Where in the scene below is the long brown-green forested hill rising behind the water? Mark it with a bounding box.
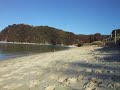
[0,24,107,45]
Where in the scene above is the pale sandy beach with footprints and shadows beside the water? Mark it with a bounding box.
[0,46,120,90]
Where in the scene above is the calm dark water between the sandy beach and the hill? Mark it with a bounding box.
[0,43,67,60]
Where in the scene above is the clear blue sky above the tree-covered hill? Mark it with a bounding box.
[0,0,120,34]
